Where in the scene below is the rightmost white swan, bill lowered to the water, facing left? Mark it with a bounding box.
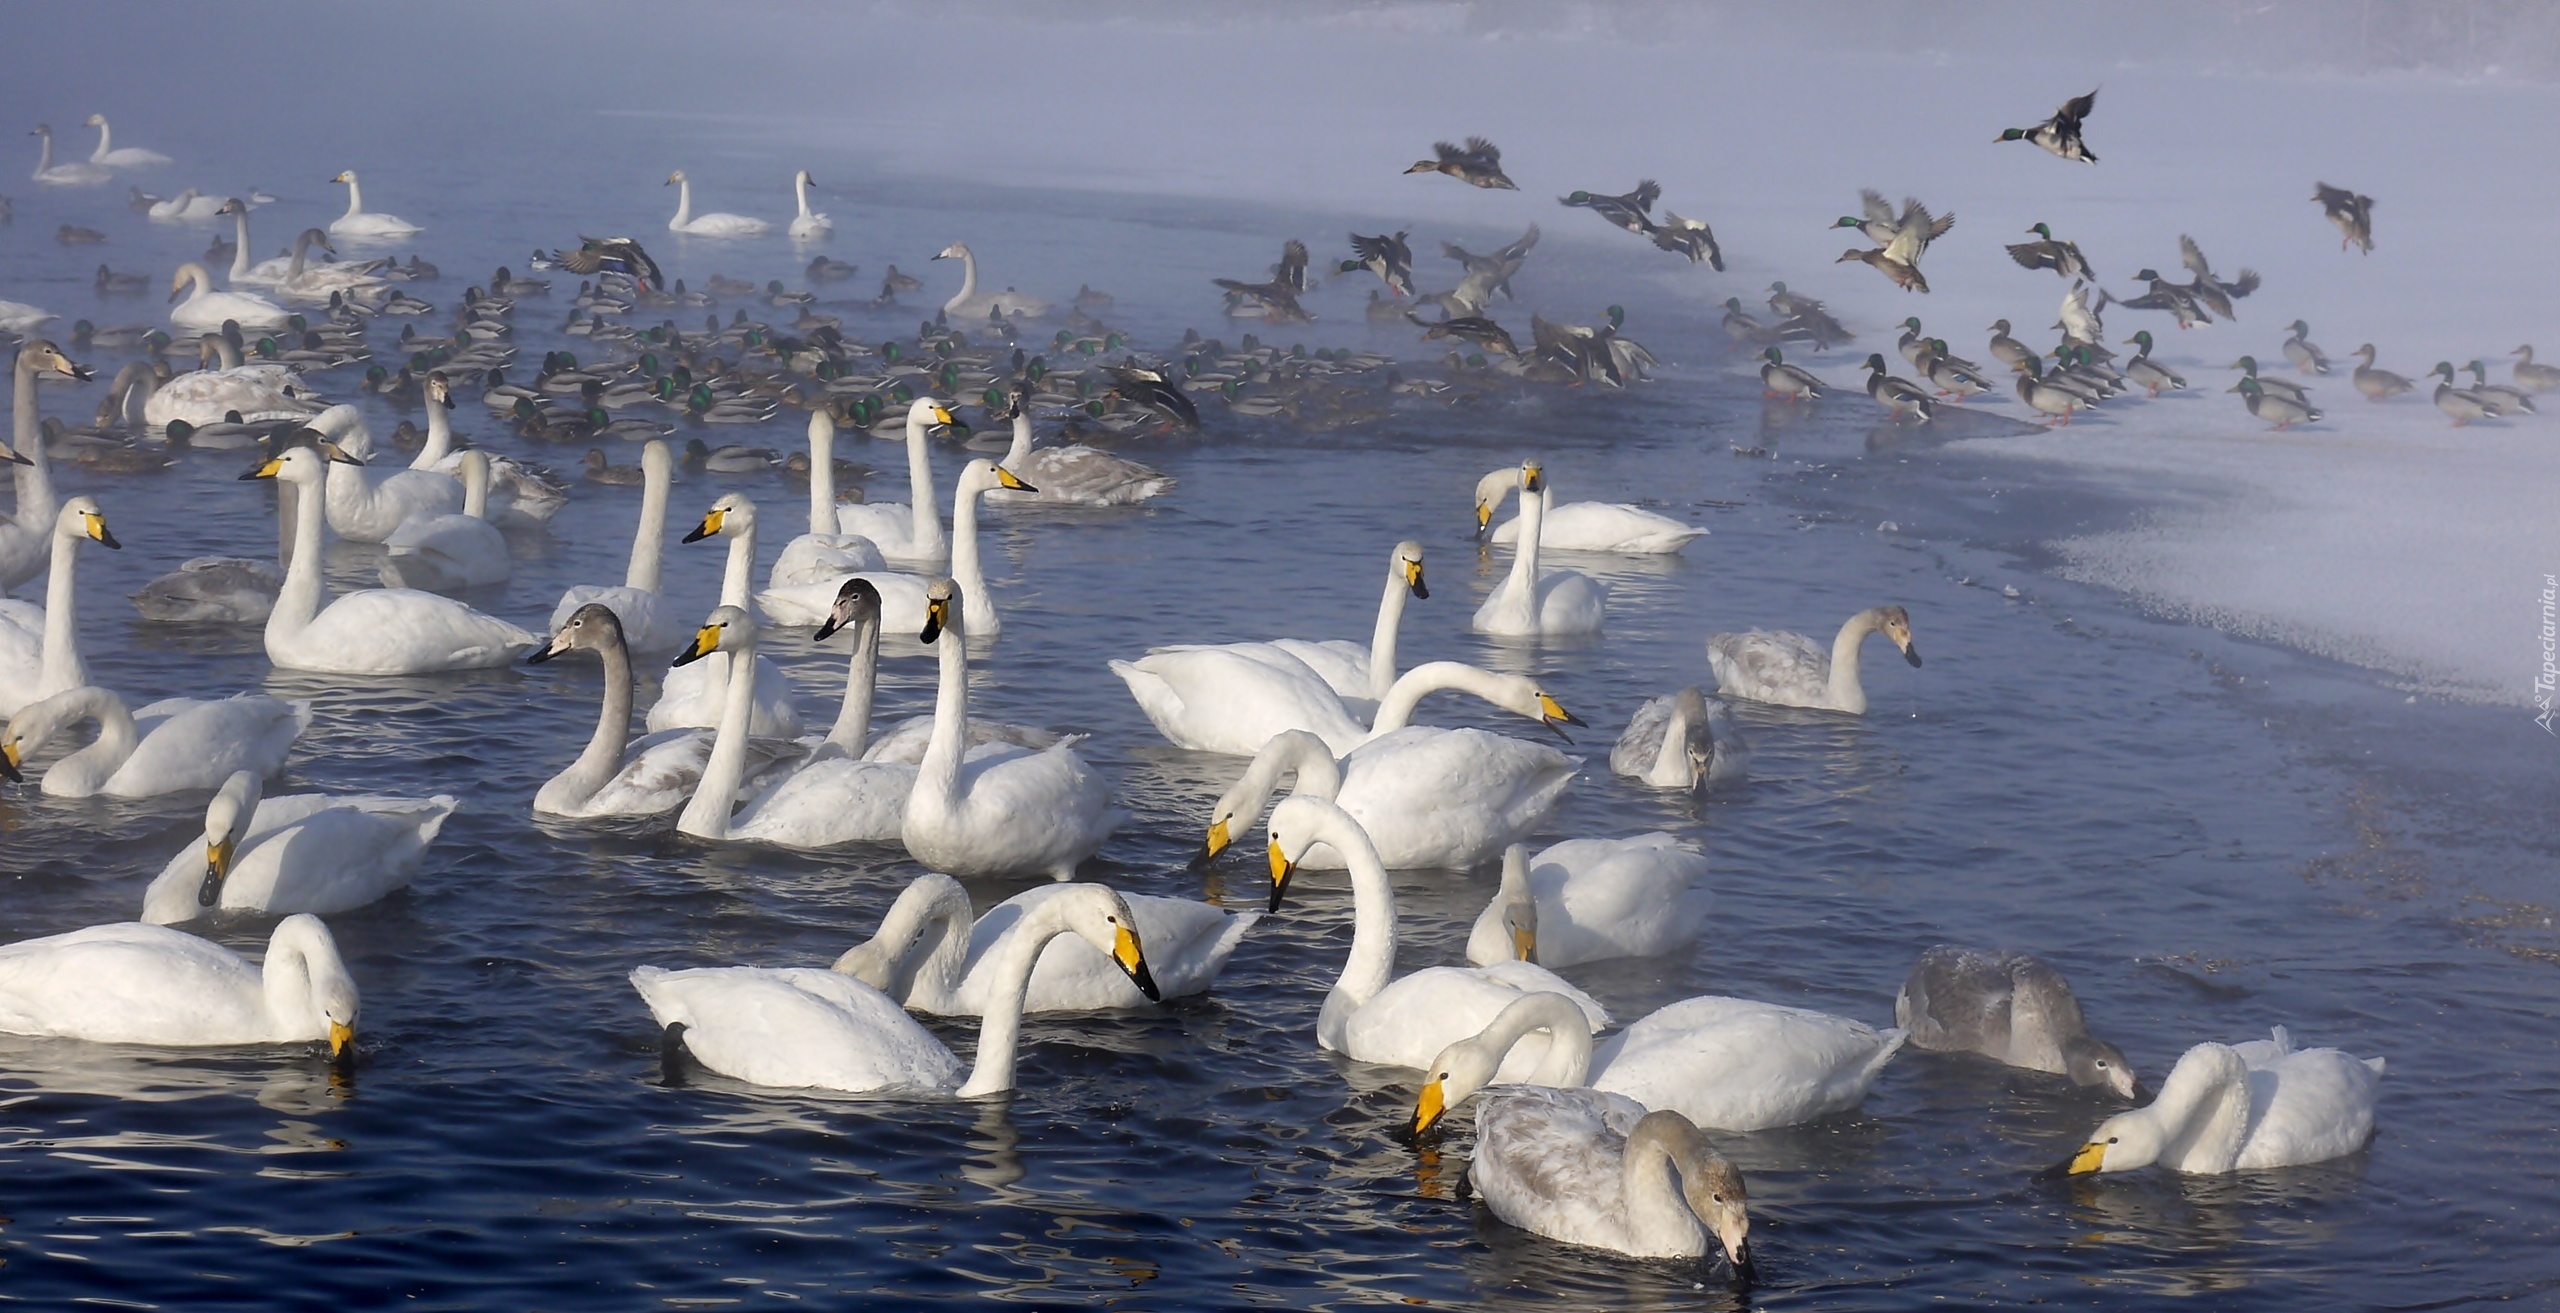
[2063,1026,2383,1175]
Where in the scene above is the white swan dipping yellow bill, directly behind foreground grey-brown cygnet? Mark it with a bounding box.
[1413,996,1905,1134]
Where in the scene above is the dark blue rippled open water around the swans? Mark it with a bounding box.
[0,58,2560,1310]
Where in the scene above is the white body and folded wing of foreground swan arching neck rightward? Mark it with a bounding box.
[632,967,960,1093]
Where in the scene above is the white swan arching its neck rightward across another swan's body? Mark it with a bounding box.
[632,886,1155,1098]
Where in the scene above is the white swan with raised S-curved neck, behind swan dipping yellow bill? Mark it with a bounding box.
[1270,796,1608,1080]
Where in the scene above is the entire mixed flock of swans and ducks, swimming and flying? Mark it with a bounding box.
[0,97,2426,1272]
